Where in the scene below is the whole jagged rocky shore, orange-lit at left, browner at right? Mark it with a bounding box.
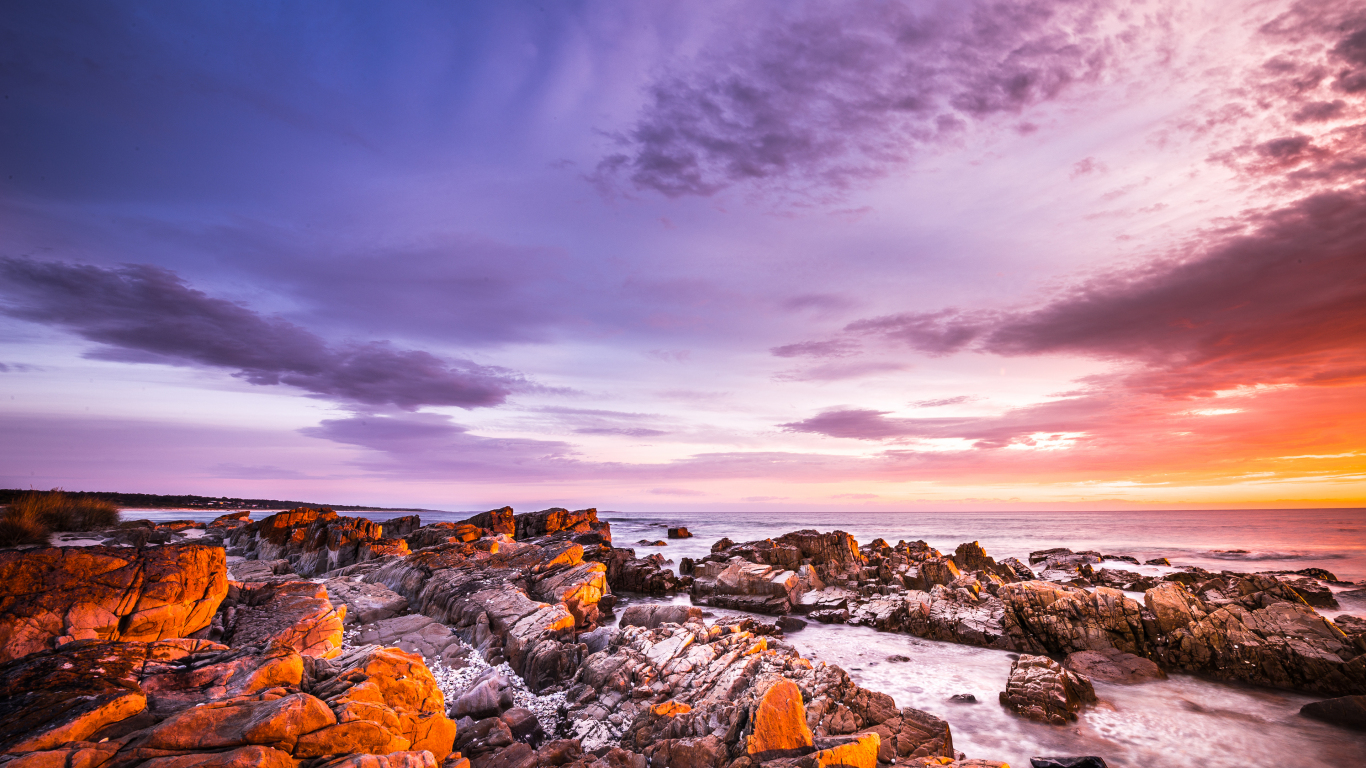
[0,507,1366,768]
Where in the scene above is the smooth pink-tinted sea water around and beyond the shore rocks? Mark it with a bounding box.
[124,510,1366,768]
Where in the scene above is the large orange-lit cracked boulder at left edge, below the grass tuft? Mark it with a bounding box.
[0,544,228,661]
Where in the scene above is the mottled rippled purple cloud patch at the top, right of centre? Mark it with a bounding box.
[598,0,1160,197]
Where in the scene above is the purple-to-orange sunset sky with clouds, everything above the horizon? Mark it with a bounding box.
[0,0,1366,512]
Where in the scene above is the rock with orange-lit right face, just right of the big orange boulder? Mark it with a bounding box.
[223,581,346,659]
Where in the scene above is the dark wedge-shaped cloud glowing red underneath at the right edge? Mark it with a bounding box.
[847,184,1366,396]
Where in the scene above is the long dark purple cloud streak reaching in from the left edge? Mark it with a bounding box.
[0,257,527,410]
